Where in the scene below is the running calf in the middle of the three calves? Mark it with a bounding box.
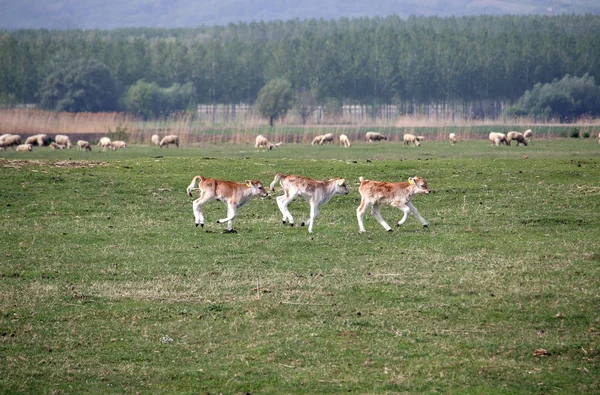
[270,174,349,233]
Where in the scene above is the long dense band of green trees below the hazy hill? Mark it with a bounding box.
[0,15,600,120]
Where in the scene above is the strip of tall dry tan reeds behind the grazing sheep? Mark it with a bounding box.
[0,110,600,144]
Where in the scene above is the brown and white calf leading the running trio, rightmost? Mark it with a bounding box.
[356,177,429,233]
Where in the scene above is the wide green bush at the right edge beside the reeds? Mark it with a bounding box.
[508,74,600,121]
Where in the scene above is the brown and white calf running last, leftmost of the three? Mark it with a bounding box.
[187,176,268,233]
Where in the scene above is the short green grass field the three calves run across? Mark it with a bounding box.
[0,139,600,394]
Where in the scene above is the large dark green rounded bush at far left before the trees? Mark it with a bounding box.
[38,52,118,112]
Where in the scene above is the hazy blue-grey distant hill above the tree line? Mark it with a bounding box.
[0,0,600,29]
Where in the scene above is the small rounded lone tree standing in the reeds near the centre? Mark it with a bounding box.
[256,79,294,126]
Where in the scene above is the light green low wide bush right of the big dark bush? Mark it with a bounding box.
[122,80,194,118]
